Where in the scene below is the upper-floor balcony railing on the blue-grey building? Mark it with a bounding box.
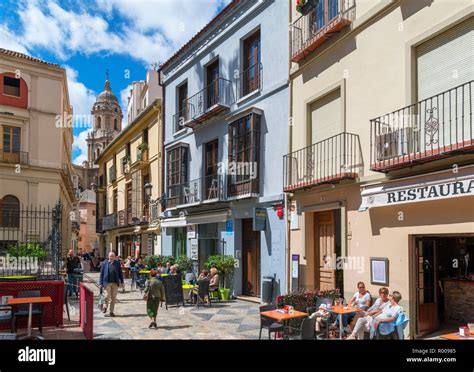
[173,78,234,131]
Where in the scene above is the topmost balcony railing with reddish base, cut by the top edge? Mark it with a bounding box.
[291,0,355,62]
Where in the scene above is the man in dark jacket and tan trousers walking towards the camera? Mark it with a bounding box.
[99,252,123,316]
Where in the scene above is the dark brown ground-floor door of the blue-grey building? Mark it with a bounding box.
[242,219,260,297]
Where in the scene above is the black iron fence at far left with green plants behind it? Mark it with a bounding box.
[0,203,62,280]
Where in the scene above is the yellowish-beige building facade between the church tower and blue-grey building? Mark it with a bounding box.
[97,100,162,257]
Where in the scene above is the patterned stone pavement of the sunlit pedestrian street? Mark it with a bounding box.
[85,273,266,340]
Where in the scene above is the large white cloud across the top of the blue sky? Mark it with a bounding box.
[12,0,230,64]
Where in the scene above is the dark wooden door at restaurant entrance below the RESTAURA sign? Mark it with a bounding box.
[415,238,439,336]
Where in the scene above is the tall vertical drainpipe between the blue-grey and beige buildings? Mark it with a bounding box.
[283,2,293,293]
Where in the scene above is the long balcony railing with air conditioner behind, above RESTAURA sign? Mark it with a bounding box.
[370,81,474,172]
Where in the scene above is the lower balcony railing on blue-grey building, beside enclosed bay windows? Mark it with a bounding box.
[166,174,225,208]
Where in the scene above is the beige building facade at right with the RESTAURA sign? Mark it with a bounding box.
[284,0,474,337]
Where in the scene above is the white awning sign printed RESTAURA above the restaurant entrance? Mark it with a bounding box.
[359,166,474,212]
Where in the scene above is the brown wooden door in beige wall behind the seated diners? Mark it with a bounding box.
[314,210,336,290]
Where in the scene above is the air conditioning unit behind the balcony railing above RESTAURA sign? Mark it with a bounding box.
[375,127,420,161]
